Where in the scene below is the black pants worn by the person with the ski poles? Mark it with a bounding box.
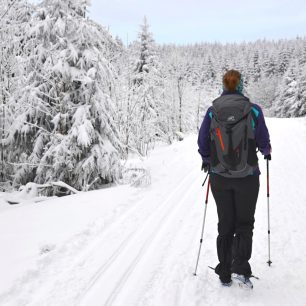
[210,174,259,282]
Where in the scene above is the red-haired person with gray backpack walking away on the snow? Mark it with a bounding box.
[198,70,271,287]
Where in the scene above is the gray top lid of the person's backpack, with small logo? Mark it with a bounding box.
[213,94,252,124]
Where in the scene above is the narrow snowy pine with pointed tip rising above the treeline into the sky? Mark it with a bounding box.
[129,17,162,155]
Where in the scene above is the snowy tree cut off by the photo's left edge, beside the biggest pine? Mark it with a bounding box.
[0,0,33,188]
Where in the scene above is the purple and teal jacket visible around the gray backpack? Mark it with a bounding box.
[198,91,271,175]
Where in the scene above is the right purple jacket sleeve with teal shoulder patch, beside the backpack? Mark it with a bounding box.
[253,104,271,155]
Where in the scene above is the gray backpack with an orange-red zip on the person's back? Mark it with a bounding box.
[210,94,258,178]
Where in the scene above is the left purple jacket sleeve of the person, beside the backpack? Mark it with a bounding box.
[198,107,211,162]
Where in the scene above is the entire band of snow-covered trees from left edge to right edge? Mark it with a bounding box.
[0,0,306,190]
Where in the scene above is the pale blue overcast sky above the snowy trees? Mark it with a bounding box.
[90,0,306,44]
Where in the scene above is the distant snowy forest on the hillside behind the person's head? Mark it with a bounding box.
[160,37,306,117]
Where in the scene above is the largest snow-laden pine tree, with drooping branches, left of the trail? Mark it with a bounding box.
[6,0,121,190]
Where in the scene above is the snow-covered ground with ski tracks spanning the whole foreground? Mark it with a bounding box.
[0,118,306,306]
